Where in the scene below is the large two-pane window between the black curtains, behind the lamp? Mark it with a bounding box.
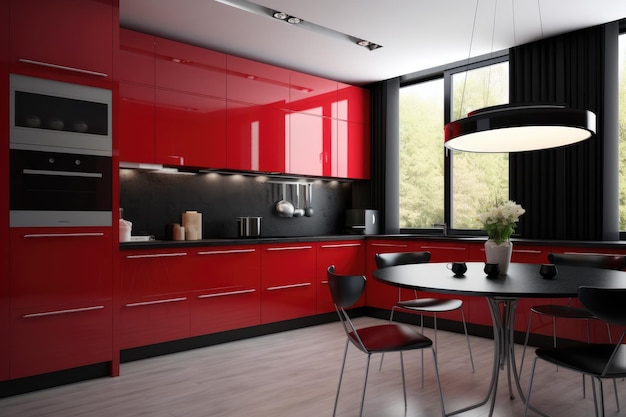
[399,58,509,229]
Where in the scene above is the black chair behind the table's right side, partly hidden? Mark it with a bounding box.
[519,253,626,410]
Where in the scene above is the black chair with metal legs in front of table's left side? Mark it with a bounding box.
[327,265,445,416]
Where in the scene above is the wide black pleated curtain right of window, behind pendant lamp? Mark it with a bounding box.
[510,22,619,240]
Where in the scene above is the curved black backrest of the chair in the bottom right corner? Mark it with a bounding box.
[578,287,626,326]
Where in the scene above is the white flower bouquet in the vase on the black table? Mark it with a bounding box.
[478,200,526,245]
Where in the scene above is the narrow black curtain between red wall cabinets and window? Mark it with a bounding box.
[370,78,400,234]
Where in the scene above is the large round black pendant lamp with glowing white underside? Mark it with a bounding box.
[444,0,596,153]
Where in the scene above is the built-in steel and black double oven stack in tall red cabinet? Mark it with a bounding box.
[9,74,112,227]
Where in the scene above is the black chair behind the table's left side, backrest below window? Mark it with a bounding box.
[374,251,474,385]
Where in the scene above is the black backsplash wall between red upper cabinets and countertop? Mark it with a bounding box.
[120,169,352,240]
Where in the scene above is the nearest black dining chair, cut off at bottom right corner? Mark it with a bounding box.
[524,286,626,417]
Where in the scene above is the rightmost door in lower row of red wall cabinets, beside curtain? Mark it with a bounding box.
[332,120,370,179]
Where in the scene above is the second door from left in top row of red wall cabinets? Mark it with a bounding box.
[156,38,226,99]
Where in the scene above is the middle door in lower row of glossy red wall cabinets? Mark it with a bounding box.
[226,101,290,173]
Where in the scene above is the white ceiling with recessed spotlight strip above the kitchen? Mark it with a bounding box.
[120,0,626,84]
